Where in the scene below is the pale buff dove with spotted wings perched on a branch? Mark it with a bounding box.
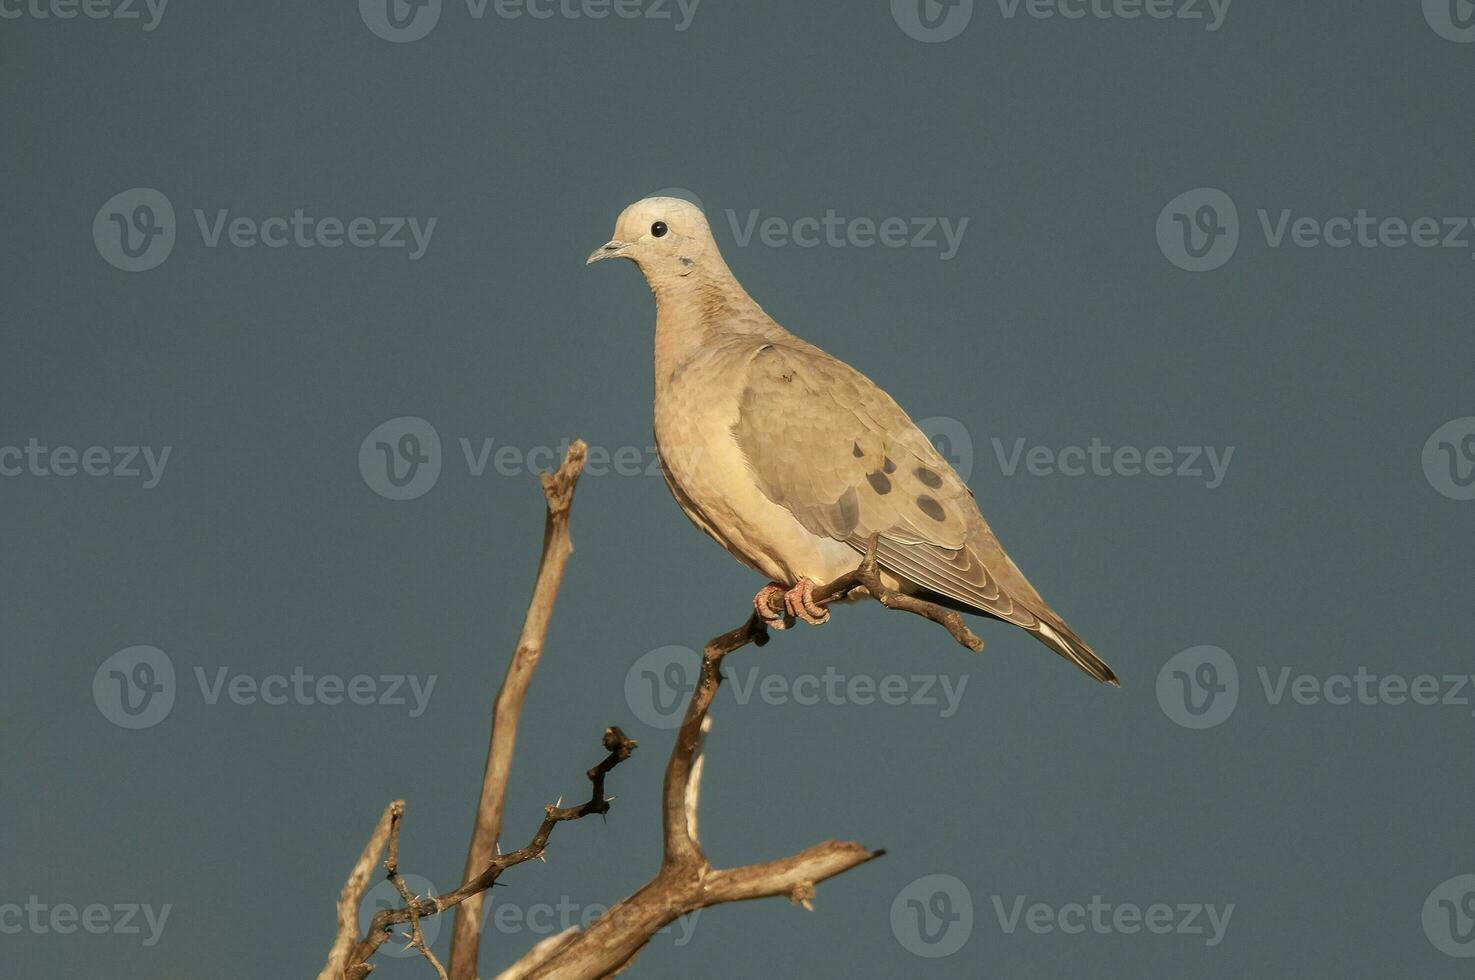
[587,198,1120,686]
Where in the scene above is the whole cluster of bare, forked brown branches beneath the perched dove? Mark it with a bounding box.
[319,441,984,980]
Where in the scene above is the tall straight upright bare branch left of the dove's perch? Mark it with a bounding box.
[450,440,589,980]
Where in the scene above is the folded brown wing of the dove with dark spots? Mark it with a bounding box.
[733,342,1053,630]
